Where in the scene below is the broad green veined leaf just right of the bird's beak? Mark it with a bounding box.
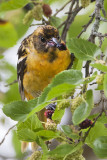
[67,38,101,60]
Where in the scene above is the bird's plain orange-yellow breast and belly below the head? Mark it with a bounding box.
[23,50,71,97]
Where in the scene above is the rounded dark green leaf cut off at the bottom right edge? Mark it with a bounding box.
[93,136,107,158]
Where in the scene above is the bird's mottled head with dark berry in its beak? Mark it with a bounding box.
[33,25,66,53]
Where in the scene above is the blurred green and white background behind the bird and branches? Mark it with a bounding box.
[0,0,107,160]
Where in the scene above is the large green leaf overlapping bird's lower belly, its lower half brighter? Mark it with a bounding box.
[39,69,82,103]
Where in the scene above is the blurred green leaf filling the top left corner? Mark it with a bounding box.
[0,0,30,12]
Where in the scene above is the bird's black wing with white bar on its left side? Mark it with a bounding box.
[17,44,27,100]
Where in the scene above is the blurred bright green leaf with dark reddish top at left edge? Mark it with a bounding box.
[0,21,18,48]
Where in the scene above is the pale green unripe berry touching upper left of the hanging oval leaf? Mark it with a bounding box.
[71,96,83,113]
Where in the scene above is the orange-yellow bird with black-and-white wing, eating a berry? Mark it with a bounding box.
[17,25,72,151]
